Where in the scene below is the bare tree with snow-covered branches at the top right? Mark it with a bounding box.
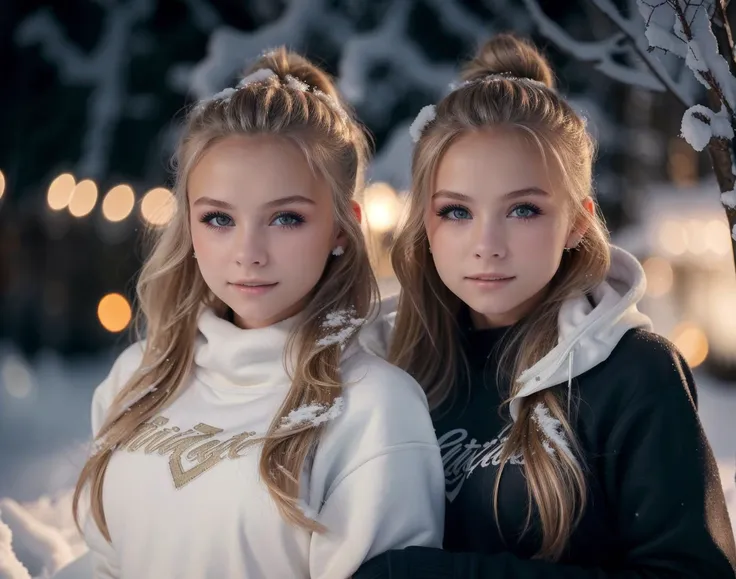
[524,0,736,267]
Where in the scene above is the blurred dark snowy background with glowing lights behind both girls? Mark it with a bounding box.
[0,0,736,572]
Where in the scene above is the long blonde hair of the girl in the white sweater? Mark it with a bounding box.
[73,48,378,541]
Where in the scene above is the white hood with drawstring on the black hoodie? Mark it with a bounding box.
[359,246,652,420]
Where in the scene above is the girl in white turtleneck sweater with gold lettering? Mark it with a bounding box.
[74,49,444,579]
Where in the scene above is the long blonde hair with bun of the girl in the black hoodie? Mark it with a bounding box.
[389,34,610,560]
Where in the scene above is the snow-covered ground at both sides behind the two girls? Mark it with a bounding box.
[0,348,736,579]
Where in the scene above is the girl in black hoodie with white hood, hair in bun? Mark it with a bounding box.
[354,35,736,579]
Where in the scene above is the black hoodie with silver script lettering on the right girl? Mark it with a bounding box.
[353,252,736,579]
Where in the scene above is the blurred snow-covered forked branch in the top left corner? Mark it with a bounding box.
[16,0,154,177]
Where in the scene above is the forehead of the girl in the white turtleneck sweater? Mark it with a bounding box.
[187,135,322,203]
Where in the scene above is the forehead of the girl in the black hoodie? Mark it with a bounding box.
[434,128,557,197]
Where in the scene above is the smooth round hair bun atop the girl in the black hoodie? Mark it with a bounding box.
[460,34,555,88]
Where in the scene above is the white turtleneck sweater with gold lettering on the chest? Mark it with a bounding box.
[86,310,444,579]
